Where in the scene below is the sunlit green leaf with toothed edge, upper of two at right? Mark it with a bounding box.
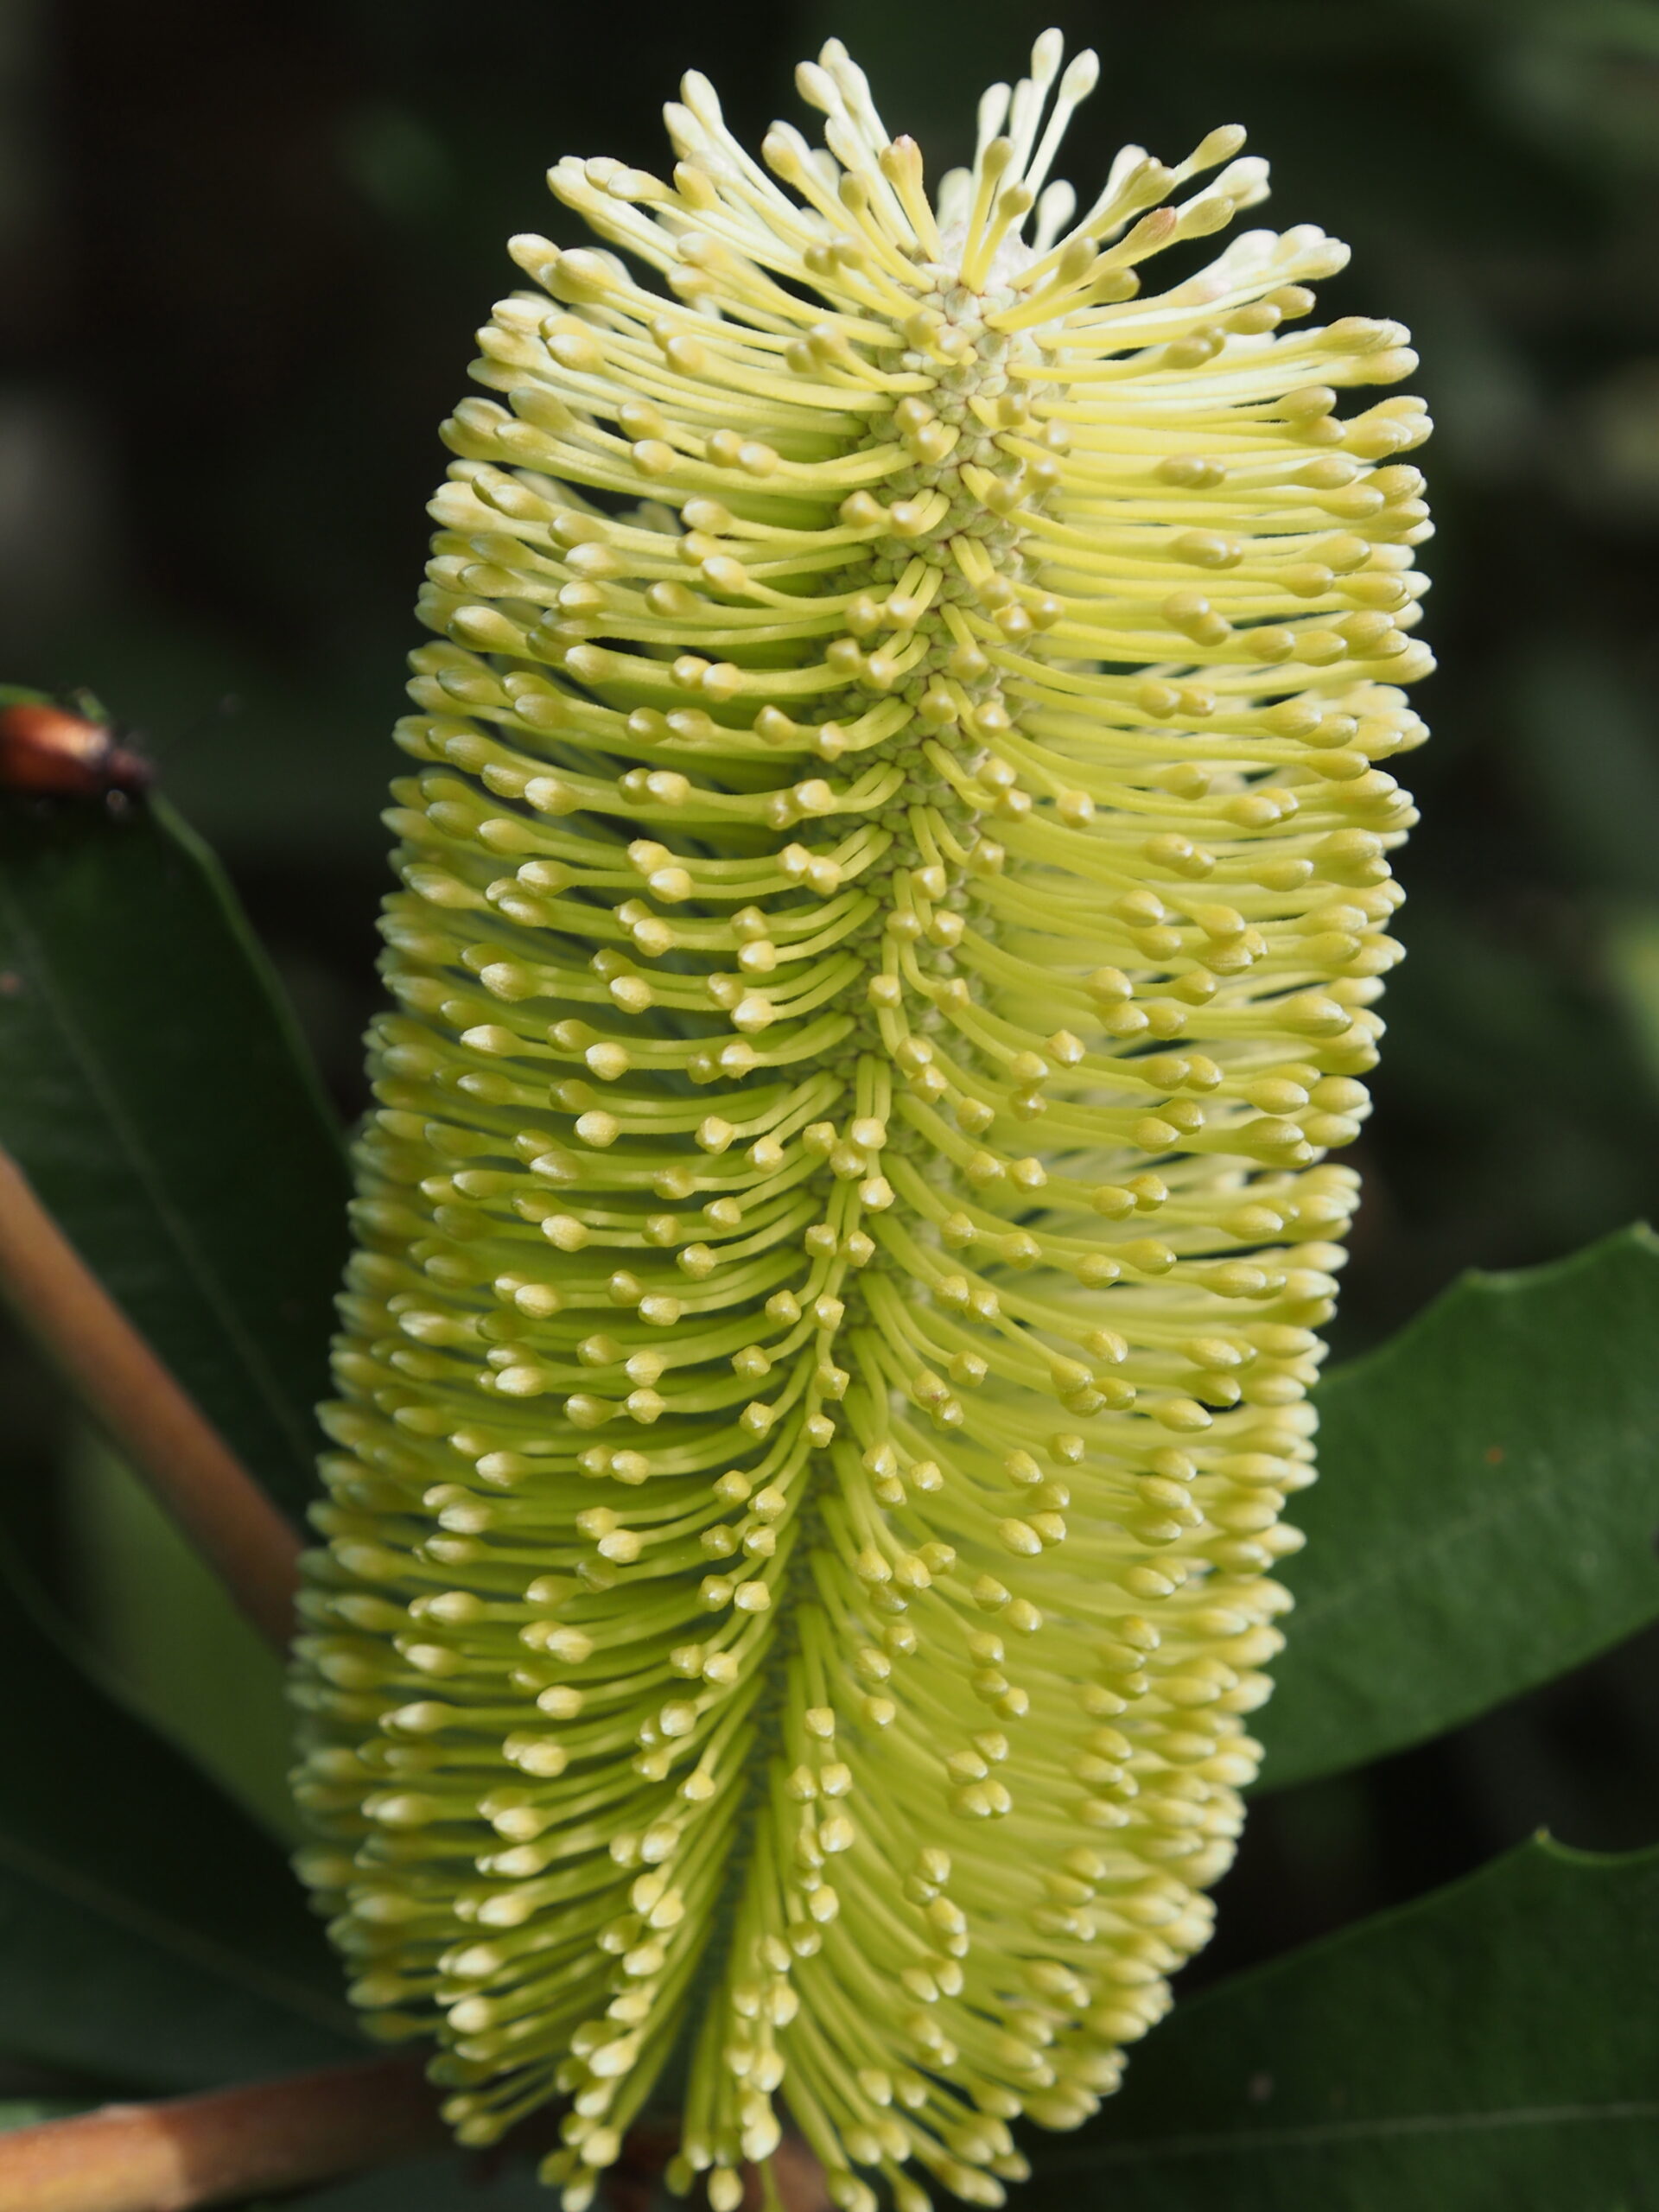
[1259,1228,1659,1787]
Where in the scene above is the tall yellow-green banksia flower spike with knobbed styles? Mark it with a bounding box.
[299,33,1429,2212]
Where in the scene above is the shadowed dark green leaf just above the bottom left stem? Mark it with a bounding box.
[0,1522,363,2094]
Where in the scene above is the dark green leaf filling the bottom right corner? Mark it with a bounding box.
[1028,1842,1659,2212]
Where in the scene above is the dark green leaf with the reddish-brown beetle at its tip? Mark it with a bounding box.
[0,760,347,1516]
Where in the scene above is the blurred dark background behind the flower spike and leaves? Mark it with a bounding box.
[0,0,1659,2052]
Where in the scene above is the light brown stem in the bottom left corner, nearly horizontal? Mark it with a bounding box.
[0,2059,449,2212]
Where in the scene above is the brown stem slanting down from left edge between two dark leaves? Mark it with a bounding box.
[0,1153,301,1650]
